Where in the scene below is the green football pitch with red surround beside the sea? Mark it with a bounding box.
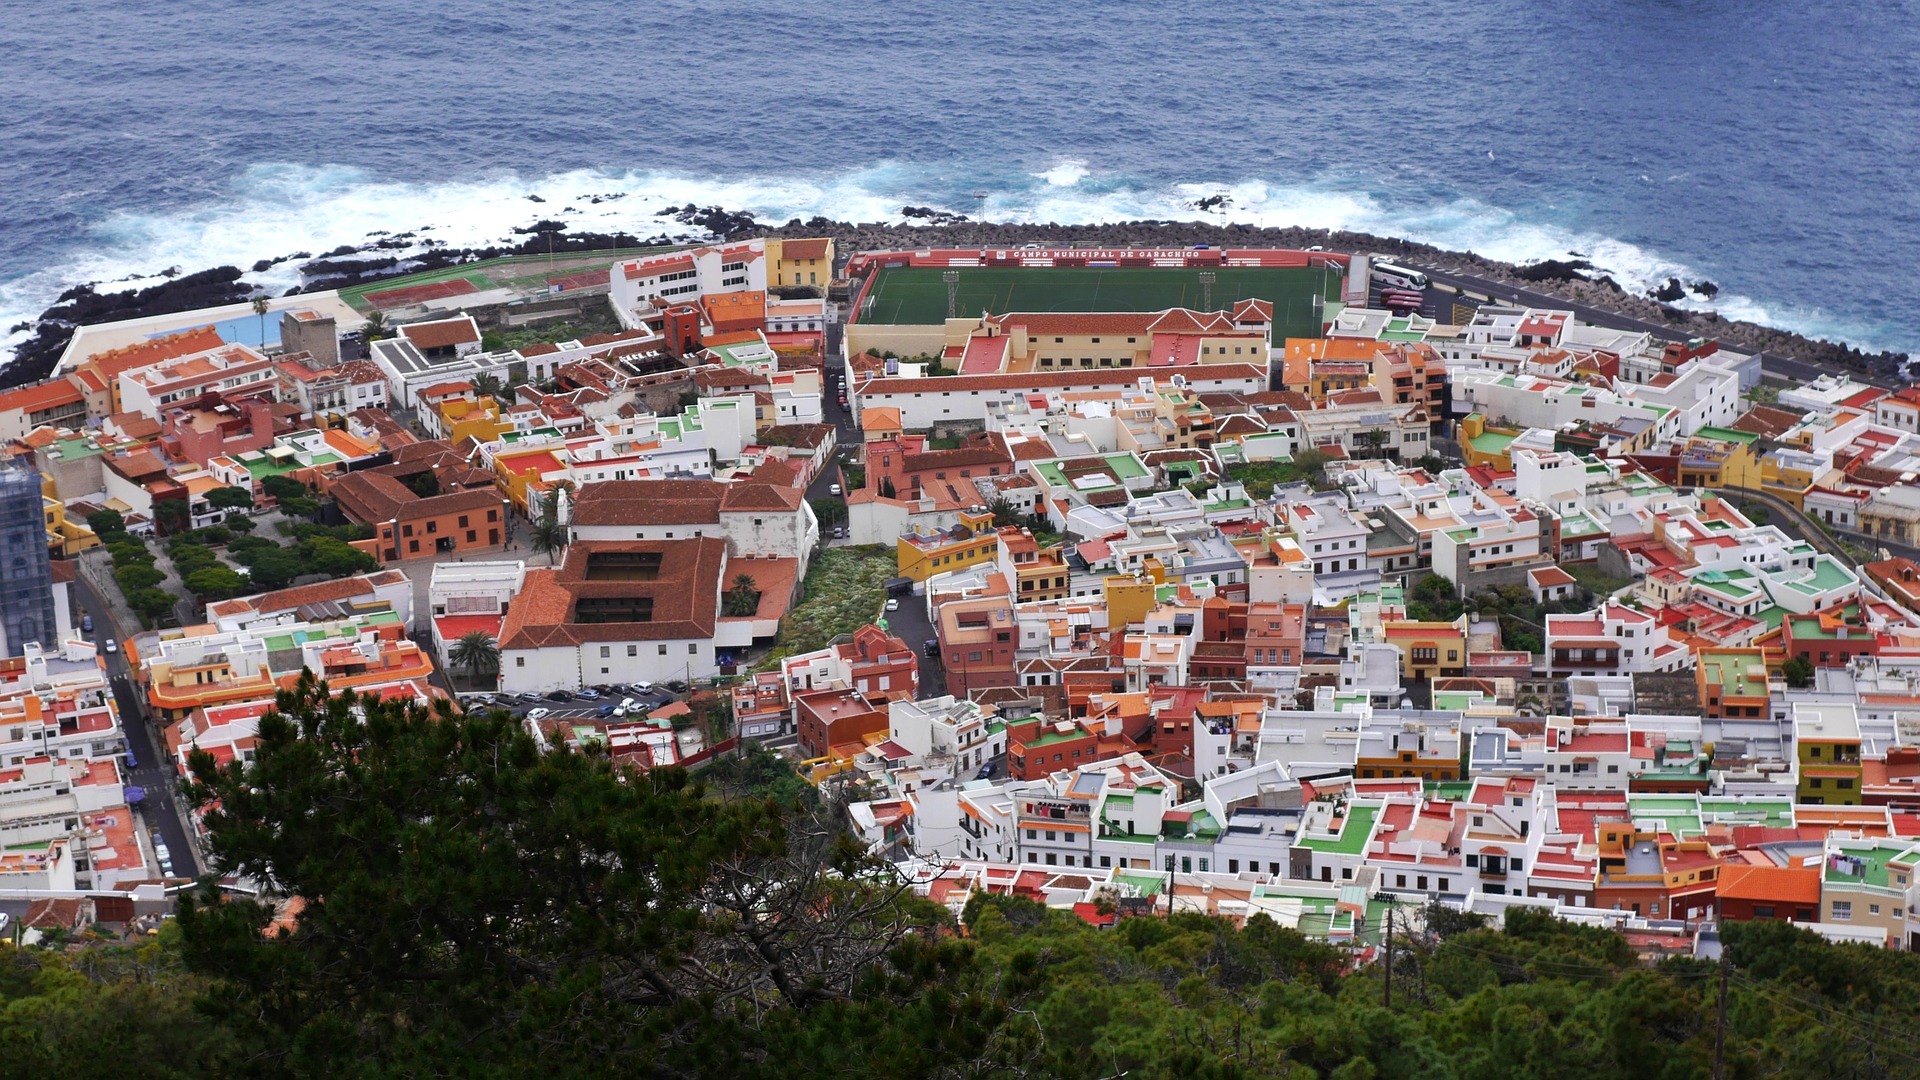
[854,267,1340,340]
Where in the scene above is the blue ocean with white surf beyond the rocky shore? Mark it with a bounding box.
[0,0,1920,352]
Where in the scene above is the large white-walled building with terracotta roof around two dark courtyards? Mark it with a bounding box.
[499,536,728,694]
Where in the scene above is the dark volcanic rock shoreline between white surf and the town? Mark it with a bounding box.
[0,204,1907,388]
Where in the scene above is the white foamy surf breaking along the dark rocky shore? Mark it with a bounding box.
[0,158,1912,350]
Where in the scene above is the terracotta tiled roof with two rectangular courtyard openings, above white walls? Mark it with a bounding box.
[499,536,726,650]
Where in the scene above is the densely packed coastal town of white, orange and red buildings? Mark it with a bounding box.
[0,238,1920,955]
